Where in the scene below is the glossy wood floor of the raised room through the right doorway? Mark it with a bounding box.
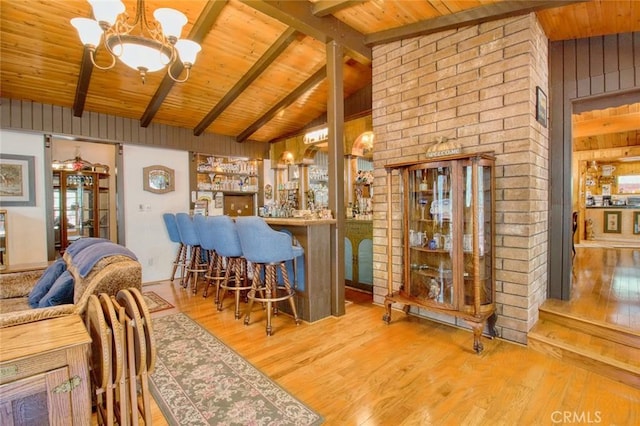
[546,247,640,330]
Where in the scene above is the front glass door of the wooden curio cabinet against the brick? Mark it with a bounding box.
[405,165,456,307]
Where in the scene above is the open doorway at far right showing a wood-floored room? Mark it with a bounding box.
[559,99,640,329]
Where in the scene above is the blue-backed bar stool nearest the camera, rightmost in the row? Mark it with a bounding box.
[236,216,304,336]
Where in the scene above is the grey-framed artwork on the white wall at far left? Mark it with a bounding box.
[0,154,36,206]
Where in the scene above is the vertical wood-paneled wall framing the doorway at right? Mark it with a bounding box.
[549,32,640,300]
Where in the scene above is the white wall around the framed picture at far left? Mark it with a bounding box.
[0,129,47,266]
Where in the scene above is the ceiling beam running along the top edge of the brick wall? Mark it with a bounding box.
[364,0,585,46]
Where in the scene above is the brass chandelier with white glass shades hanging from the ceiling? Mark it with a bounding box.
[71,0,200,84]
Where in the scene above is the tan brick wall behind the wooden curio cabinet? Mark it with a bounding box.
[372,14,549,343]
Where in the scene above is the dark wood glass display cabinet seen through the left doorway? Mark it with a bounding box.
[53,170,110,253]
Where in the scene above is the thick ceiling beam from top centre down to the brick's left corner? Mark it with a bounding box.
[242,0,371,65]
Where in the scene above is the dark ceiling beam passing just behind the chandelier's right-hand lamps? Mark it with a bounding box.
[140,0,228,127]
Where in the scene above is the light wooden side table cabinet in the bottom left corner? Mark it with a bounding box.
[0,315,91,425]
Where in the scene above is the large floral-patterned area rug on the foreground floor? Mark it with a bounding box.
[150,313,323,426]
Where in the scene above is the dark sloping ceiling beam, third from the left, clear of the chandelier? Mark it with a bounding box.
[193,27,300,136]
